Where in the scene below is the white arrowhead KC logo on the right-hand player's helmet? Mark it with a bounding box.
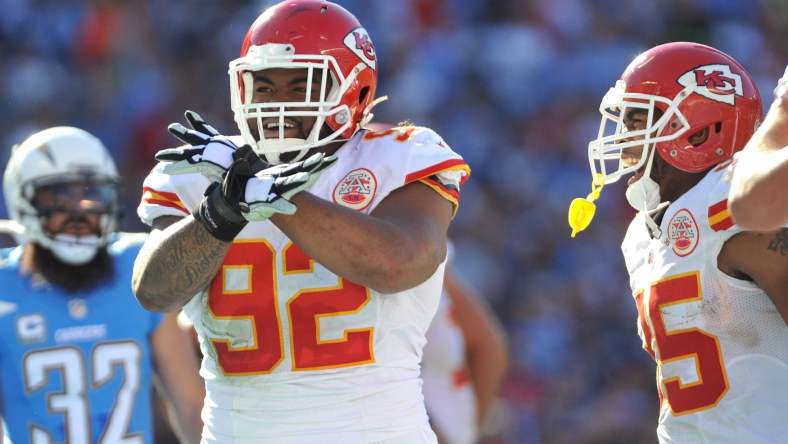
[678,65,744,105]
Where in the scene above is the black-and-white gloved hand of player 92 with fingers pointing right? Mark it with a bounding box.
[243,153,337,221]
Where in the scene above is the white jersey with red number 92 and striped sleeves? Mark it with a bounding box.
[138,127,469,444]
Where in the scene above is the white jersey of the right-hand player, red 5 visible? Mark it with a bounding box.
[622,167,788,444]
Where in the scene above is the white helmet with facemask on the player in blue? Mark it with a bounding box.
[2,126,119,265]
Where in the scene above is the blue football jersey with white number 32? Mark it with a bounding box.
[0,235,162,444]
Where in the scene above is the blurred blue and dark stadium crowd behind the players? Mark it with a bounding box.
[0,0,788,444]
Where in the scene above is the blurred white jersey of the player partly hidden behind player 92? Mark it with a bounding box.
[421,290,477,444]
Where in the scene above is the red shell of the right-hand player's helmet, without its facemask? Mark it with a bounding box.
[621,42,763,173]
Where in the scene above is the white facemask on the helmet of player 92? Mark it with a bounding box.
[229,43,358,163]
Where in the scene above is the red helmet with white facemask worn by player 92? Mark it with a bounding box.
[229,0,378,162]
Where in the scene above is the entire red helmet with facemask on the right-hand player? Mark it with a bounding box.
[588,42,763,183]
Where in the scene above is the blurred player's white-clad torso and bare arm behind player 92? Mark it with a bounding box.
[421,264,509,444]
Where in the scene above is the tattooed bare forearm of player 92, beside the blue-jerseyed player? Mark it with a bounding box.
[138,218,230,309]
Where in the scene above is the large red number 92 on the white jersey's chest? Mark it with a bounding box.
[208,240,375,376]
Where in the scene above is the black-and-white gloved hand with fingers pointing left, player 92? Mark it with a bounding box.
[156,111,238,182]
